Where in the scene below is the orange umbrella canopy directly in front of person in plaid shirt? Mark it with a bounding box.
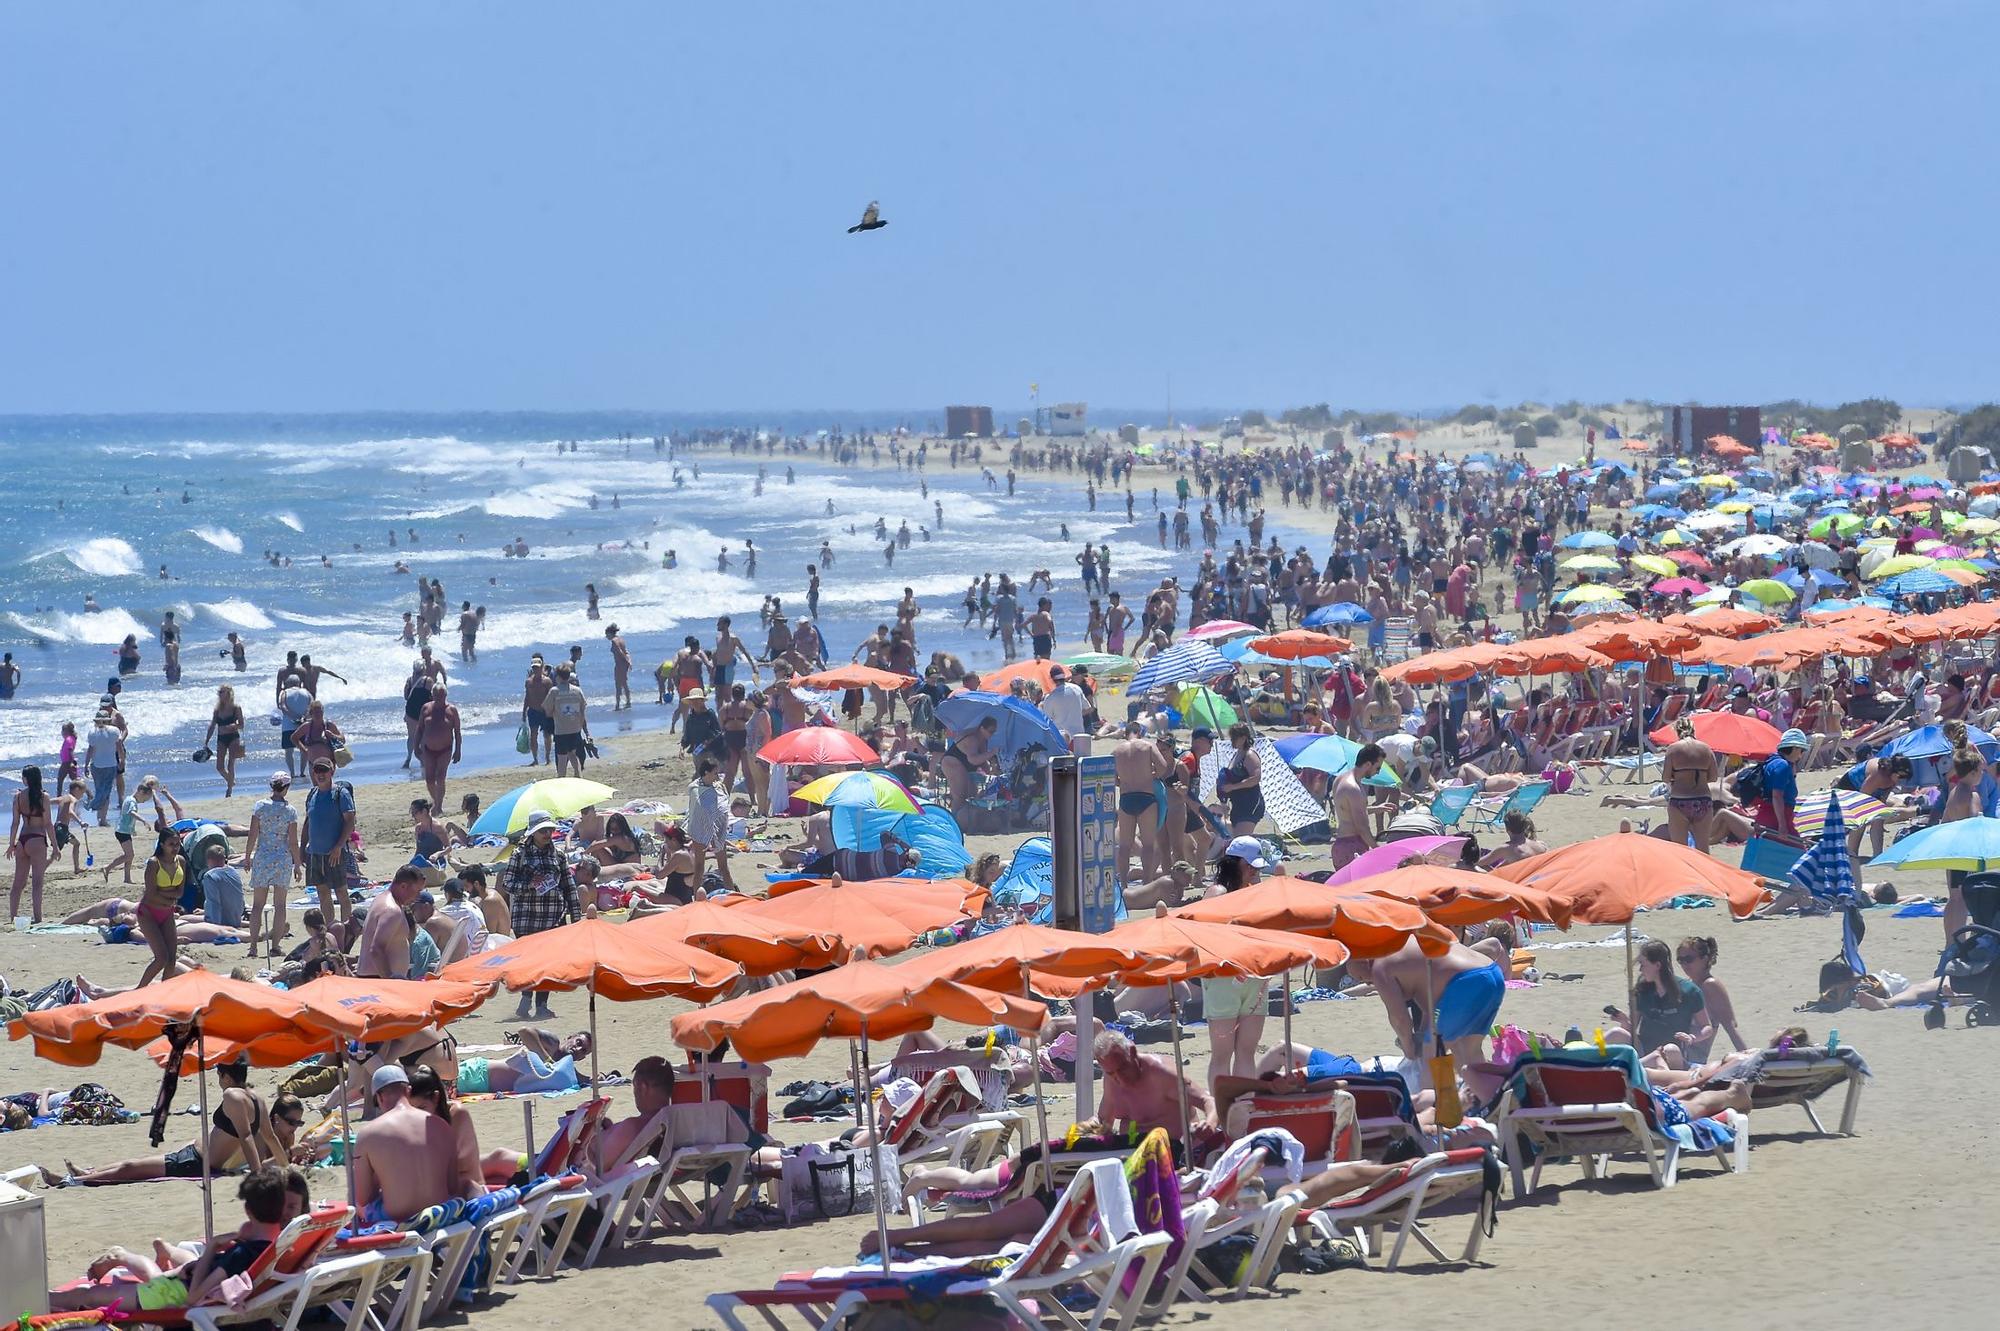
[444,919,742,1003]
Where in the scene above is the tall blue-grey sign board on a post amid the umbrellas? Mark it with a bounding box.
[1048,753,1120,1123]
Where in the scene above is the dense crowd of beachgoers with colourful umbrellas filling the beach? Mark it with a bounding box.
[0,421,2000,1313]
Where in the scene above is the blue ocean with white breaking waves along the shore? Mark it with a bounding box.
[0,414,1290,795]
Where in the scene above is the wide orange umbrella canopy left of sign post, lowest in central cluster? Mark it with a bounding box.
[670,961,1048,1061]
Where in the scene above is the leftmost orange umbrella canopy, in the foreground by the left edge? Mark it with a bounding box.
[8,971,324,1067]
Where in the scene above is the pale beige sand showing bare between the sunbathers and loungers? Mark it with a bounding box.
[0,421,1976,1331]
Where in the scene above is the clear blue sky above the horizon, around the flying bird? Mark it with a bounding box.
[0,0,2000,414]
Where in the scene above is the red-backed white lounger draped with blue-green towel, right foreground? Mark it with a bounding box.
[1494,1045,1750,1199]
